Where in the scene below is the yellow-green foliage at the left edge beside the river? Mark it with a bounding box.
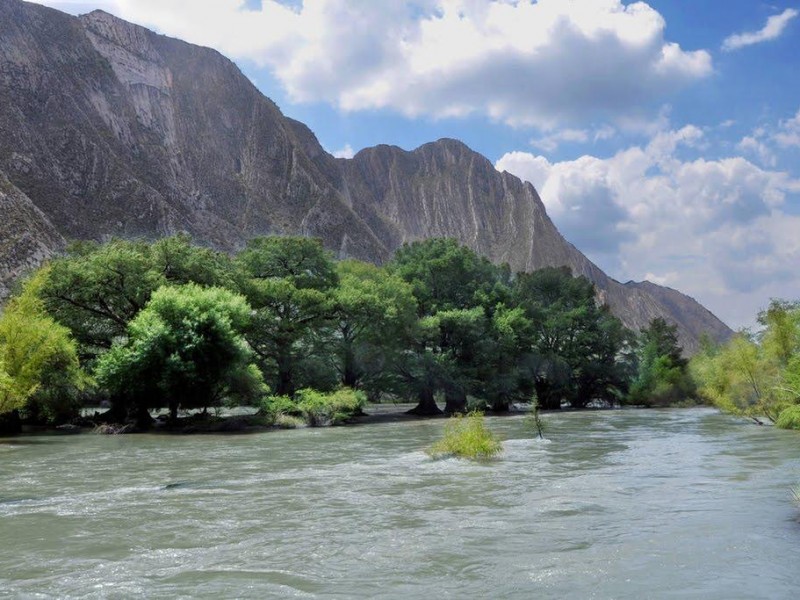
[0,269,86,422]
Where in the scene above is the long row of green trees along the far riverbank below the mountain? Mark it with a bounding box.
[0,235,700,434]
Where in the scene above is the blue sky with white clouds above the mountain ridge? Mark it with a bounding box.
[28,0,800,328]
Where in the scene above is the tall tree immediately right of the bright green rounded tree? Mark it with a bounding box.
[235,237,337,396]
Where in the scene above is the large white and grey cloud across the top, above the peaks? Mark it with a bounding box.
[28,0,712,129]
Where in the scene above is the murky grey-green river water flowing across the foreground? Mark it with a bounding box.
[0,409,800,600]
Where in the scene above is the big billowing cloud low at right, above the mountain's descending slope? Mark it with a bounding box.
[496,125,800,326]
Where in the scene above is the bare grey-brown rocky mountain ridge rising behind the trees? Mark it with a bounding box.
[0,0,730,350]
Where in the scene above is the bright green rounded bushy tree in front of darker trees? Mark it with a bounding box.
[96,284,266,422]
